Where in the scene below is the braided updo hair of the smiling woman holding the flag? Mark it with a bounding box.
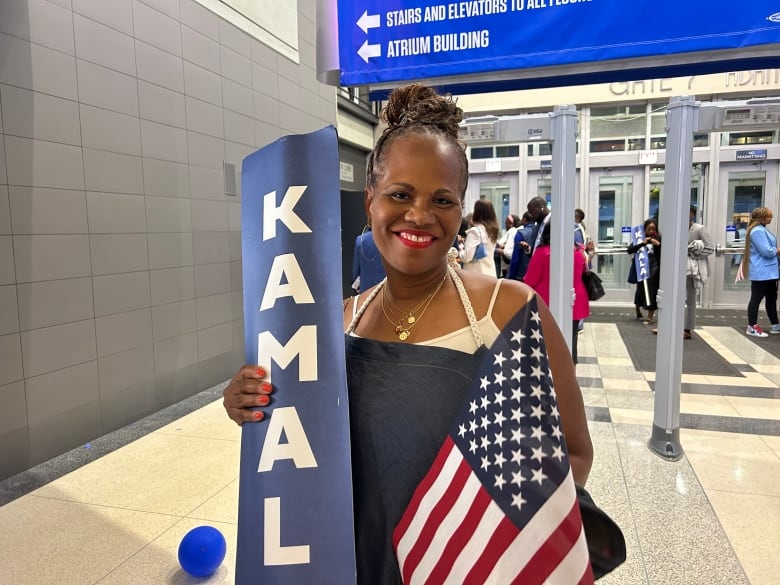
[366,83,469,199]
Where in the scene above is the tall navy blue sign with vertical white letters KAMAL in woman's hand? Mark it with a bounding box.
[236,126,355,585]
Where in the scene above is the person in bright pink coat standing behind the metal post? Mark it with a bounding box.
[523,223,590,364]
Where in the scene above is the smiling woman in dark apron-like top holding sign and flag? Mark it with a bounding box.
[224,85,593,585]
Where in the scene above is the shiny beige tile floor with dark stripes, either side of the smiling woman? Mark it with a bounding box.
[0,322,780,585]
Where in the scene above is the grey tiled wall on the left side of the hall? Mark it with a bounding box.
[0,0,336,479]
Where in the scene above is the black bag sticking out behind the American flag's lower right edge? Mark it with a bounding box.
[575,486,626,579]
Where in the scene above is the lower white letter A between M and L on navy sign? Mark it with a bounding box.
[257,406,317,473]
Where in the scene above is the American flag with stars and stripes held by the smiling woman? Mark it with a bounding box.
[393,298,593,585]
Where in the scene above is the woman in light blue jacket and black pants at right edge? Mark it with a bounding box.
[742,207,780,337]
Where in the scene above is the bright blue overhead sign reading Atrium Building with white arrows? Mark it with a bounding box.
[338,0,780,85]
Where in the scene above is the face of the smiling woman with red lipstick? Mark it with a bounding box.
[366,134,462,274]
